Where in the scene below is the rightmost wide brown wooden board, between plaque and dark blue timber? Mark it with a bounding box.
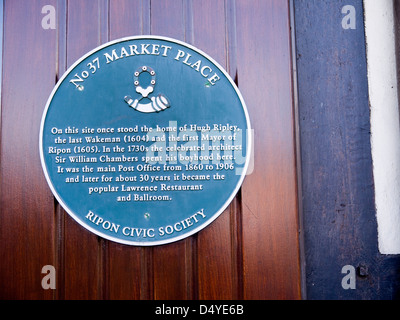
[236,0,300,299]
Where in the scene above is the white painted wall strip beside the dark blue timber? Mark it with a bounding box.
[364,0,400,254]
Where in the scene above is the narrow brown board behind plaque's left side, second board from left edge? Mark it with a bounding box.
[61,0,104,299]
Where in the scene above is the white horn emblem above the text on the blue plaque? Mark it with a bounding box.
[125,66,170,113]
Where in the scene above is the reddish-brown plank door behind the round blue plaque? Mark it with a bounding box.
[0,0,301,299]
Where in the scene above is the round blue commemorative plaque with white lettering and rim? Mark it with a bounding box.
[40,36,251,246]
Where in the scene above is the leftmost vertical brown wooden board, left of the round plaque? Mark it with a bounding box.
[0,0,56,299]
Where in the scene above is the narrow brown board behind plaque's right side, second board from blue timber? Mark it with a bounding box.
[193,0,237,299]
